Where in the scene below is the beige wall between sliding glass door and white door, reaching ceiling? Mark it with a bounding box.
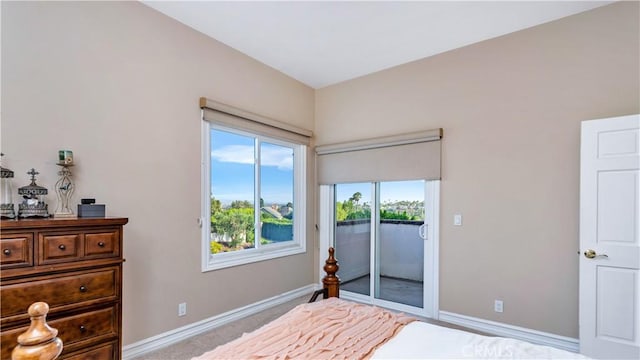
[315,2,640,337]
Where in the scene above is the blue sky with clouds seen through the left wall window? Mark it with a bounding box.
[211,130,293,205]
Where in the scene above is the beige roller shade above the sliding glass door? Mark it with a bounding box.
[316,129,442,185]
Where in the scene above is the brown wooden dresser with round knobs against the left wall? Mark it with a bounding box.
[0,218,128,360]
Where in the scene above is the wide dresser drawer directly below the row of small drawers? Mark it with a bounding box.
[0,267,120,323]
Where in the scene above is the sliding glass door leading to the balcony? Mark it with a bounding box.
[332,180,437,316]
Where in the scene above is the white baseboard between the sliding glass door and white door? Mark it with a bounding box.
[438,311,580,352]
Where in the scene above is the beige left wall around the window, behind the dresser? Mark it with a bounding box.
[1,1,315,345]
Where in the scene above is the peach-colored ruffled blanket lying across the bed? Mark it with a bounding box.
[192,298,415,360]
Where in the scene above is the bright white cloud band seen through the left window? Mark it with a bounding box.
[211,145,293,170]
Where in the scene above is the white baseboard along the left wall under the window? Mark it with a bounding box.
[122,284,319,360]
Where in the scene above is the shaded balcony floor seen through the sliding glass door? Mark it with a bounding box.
[340,275,423,308]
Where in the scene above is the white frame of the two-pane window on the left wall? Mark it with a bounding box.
[200,120,307,272]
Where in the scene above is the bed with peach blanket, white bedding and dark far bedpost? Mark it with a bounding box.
[192,248,586,360]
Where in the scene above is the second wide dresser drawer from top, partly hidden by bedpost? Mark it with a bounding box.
[0,307,118,359]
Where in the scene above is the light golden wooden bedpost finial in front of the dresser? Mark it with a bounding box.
[11,302,62,360]
